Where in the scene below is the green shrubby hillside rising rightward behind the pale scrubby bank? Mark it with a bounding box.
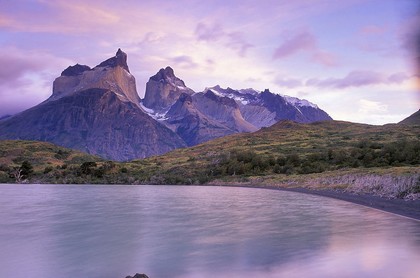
[127,121,420,184]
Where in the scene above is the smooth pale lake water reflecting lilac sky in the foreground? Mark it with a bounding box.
[0,185,420,278]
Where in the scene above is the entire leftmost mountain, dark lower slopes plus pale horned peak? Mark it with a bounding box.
[0,50,186,161]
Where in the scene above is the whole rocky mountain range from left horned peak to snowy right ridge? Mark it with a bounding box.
[0,49,332,161]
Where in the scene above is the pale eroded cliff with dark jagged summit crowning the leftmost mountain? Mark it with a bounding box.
[48,49,140,106]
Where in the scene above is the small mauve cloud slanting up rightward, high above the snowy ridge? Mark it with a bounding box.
[273,32,316,59]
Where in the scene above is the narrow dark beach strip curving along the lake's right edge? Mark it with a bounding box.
[226,185,420,221]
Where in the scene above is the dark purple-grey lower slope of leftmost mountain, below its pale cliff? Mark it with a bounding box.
[0,88,185,161]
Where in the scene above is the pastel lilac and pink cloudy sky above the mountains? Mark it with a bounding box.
[0,0,420,124]
